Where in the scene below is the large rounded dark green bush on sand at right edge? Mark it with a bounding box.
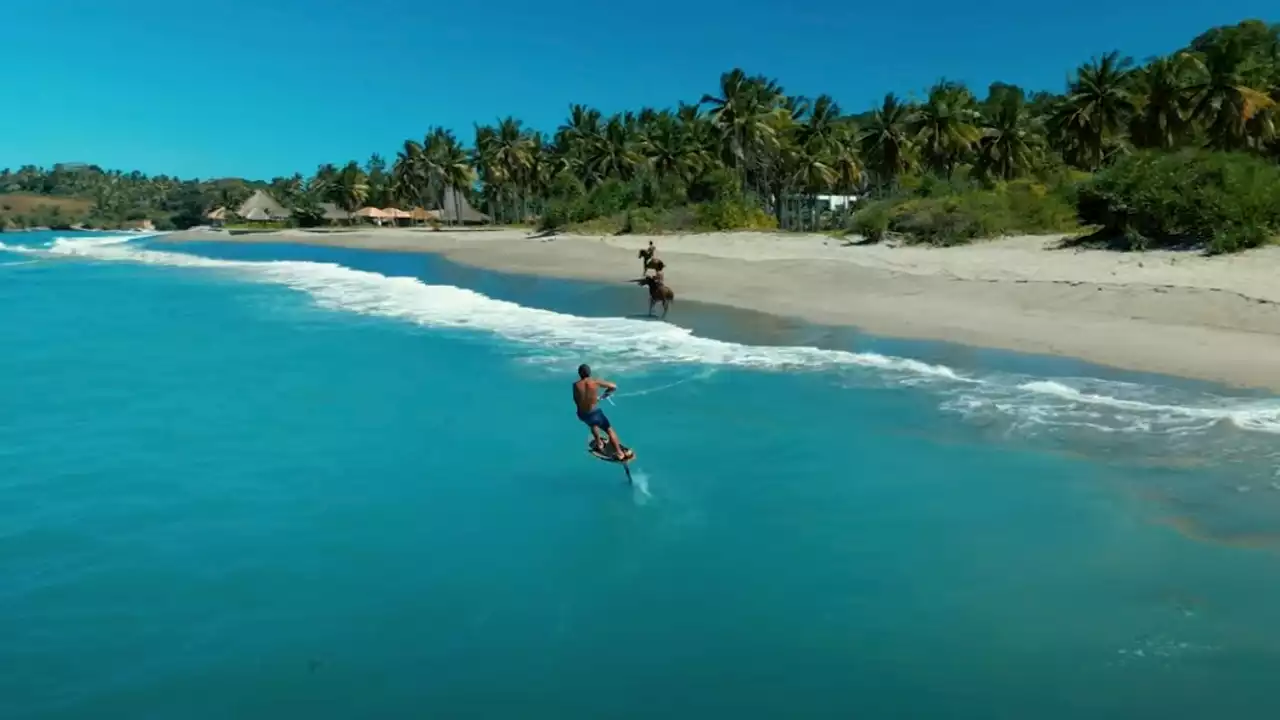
[1076,150,1280,252]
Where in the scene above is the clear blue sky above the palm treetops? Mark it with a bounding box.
[0,0,1280,179]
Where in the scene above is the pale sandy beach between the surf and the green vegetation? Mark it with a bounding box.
[166,229,1280,391]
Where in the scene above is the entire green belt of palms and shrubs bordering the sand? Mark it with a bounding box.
[0,20,1280,250]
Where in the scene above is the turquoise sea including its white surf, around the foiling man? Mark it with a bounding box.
[0,233,1280,720]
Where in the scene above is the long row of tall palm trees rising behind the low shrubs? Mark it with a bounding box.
[0,20,1280,235]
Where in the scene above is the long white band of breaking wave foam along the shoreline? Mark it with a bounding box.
[17,236,1280,434]
